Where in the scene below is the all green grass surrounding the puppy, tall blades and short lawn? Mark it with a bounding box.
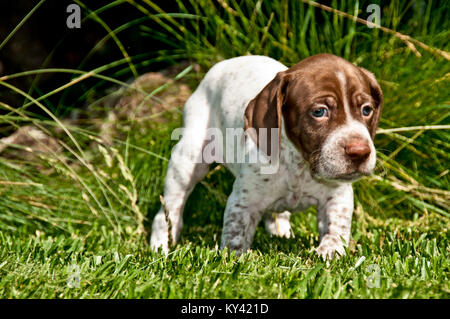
[0,0,450,298]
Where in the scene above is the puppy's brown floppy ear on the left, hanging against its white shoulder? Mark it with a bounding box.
[244,72,287,156]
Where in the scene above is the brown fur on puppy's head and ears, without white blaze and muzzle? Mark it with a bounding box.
[244,54,383,172]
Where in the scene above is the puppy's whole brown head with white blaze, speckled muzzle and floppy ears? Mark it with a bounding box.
[244,54,383,181]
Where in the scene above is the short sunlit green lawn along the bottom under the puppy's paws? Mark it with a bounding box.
[0,213,450,298]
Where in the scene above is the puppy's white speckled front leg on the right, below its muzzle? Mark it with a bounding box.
[316,184,353,259]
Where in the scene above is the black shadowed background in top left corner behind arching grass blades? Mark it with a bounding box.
[0,0,176,115]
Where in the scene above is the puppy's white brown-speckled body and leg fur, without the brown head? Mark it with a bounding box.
[151,56,380,258]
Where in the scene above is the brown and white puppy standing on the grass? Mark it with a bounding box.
[151,54,383,258]
